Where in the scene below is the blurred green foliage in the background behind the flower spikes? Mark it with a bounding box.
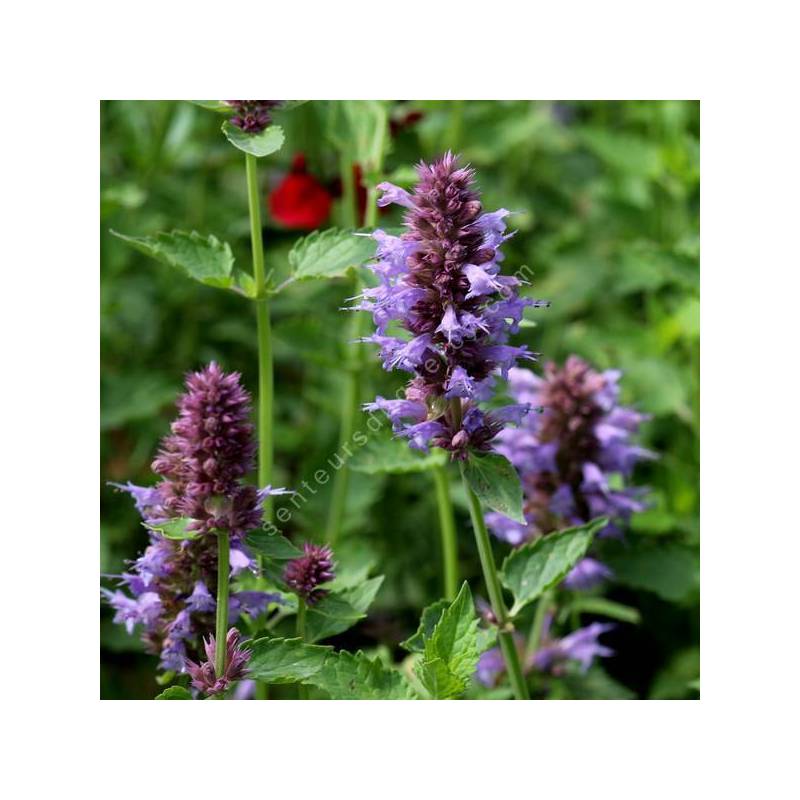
[100,101,700,698]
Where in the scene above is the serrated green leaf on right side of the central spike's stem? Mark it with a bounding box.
[500,519,607,616]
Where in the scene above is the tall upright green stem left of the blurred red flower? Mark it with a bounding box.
[245,153,275,522]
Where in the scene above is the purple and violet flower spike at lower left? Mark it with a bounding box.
[102,363,283,671]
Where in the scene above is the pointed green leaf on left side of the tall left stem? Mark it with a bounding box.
[111,230,234,289]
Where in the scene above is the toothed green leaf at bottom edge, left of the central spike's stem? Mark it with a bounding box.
[307,650,413,700]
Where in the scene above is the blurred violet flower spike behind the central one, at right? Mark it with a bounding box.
[486,356,654,552]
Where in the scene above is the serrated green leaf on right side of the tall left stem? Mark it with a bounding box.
[289,228,375,282]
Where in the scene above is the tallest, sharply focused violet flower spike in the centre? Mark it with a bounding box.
[355,153,547,459]
